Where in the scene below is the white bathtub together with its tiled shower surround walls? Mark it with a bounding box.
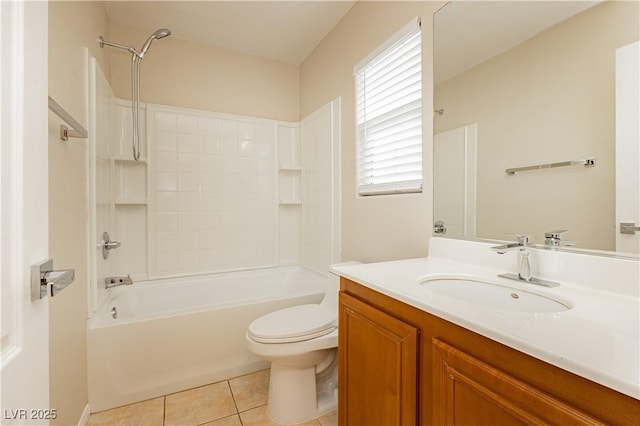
[88,53,340,411]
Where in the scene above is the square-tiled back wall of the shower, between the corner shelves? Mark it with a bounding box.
[147,105,278,277]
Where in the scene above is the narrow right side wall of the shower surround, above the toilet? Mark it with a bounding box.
[301,104,333,274]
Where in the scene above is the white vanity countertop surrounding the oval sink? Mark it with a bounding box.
[333,238,640,399]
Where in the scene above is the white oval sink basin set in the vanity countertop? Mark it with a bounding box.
[420,277,571,313]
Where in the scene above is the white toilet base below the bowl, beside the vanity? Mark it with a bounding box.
[267,350,338,425]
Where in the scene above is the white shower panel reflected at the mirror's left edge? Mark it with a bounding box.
[433,124,477,237]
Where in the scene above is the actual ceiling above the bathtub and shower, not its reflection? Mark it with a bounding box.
[105,0,355,65]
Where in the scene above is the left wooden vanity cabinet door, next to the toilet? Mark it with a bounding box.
[338,293,418,426]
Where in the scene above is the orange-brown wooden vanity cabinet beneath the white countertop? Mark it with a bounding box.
[338,278,640,426]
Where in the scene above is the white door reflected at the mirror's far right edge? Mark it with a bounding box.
[615,41,640,254]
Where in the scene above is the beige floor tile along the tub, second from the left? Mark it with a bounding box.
[164,382,237,426]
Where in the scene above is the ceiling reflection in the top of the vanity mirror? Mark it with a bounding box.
[434,0,600,84]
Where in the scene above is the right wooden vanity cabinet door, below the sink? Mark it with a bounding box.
[433,339,603,426]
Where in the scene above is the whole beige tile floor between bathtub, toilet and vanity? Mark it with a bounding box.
[87,370,338,426]
